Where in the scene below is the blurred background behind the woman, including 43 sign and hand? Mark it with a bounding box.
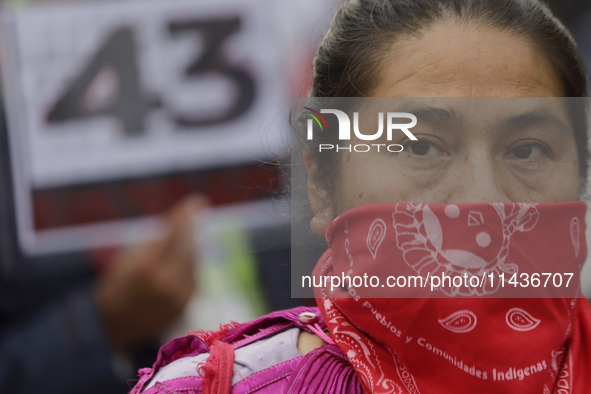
[0,0,591,393]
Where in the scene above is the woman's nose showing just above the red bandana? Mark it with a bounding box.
[447,149,511,204]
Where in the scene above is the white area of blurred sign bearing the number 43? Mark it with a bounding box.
[1,0,288,252]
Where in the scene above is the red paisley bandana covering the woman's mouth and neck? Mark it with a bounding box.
[314,202,591,394]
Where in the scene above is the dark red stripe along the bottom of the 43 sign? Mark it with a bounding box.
[33,164,281,230]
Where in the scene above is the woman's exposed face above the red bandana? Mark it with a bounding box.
[310,24,579,234]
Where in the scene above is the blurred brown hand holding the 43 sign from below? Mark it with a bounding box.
[95,197,207,352]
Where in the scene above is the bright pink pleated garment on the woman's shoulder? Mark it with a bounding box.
[130,307,363,394]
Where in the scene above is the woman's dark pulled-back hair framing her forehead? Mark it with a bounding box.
[307,0,589,209]
